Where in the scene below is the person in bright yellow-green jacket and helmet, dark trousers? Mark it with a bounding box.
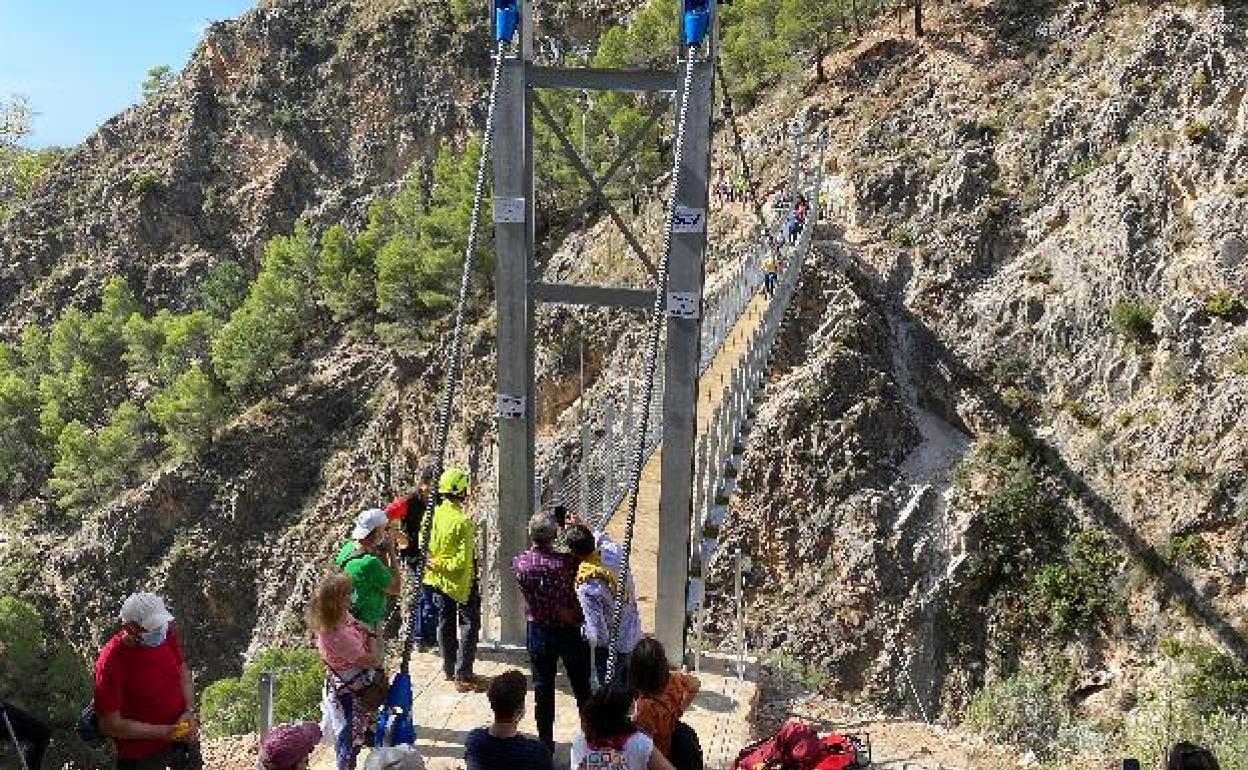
[424,468,487,693]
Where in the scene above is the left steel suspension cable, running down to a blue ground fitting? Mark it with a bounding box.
[401,40,507,674]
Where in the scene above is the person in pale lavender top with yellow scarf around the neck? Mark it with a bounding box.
[564,523,641,690]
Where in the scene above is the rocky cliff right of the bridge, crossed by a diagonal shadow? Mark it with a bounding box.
[716,1,1248,728]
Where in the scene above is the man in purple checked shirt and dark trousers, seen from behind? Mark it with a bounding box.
[512,512,592,751]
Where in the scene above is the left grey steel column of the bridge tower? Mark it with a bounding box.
[483,1,534,645]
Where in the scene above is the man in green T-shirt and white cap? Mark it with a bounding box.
[334,508,403,660]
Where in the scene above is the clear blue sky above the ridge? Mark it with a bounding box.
[0,0,256,147]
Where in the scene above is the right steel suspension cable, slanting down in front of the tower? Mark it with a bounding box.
[604,45,698,686]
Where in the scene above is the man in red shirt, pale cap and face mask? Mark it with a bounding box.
[95,593,203,770]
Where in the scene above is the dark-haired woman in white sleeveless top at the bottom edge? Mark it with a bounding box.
[572,688,675,770]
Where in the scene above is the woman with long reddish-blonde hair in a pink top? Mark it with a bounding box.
[307,573,381,770]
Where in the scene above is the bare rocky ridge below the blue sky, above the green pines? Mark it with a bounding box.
[0,0,488,328]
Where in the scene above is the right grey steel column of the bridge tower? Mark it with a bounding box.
[654,44,715,661]
